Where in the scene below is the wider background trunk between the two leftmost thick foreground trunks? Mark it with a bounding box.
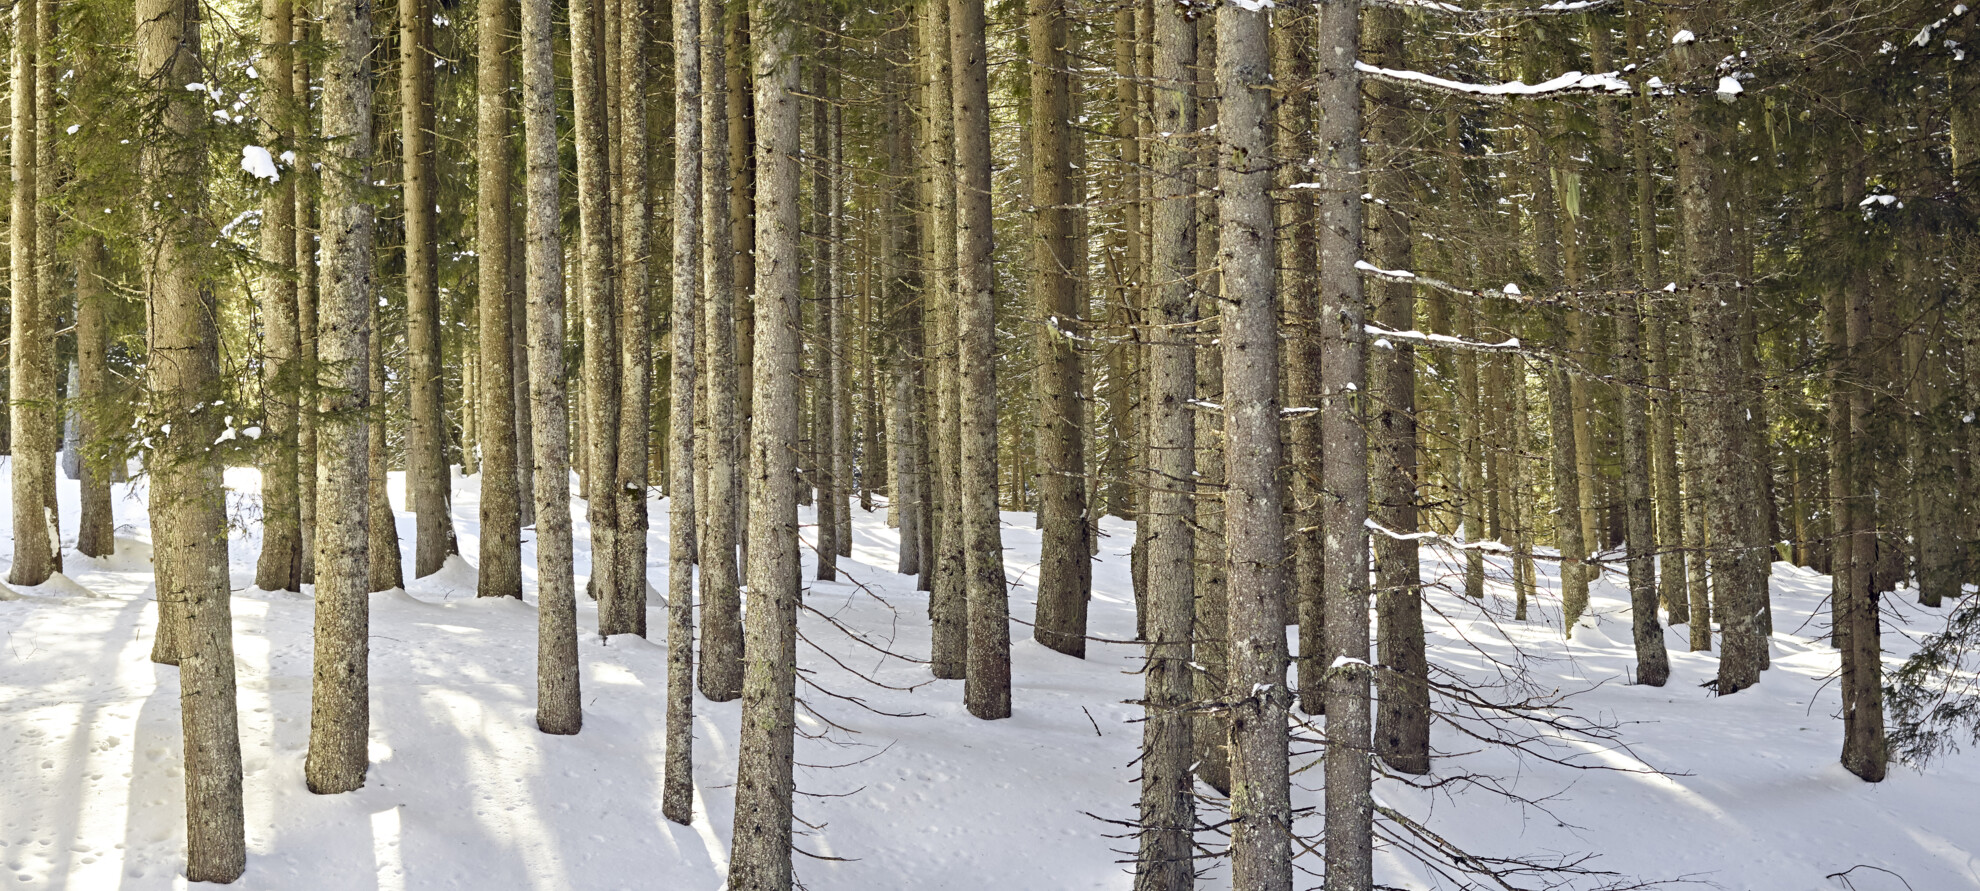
[253,0,303,590]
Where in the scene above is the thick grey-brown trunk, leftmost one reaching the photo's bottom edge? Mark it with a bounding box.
[729,0,802,891]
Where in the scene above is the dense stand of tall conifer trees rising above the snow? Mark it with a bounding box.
[6,0,1980,889]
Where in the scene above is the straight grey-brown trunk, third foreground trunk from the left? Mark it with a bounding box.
[523,0,584,735]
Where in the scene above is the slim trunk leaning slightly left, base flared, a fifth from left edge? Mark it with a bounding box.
[398,0,459,578]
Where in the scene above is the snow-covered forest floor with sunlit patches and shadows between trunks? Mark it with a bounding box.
[0,471,1980,891]
